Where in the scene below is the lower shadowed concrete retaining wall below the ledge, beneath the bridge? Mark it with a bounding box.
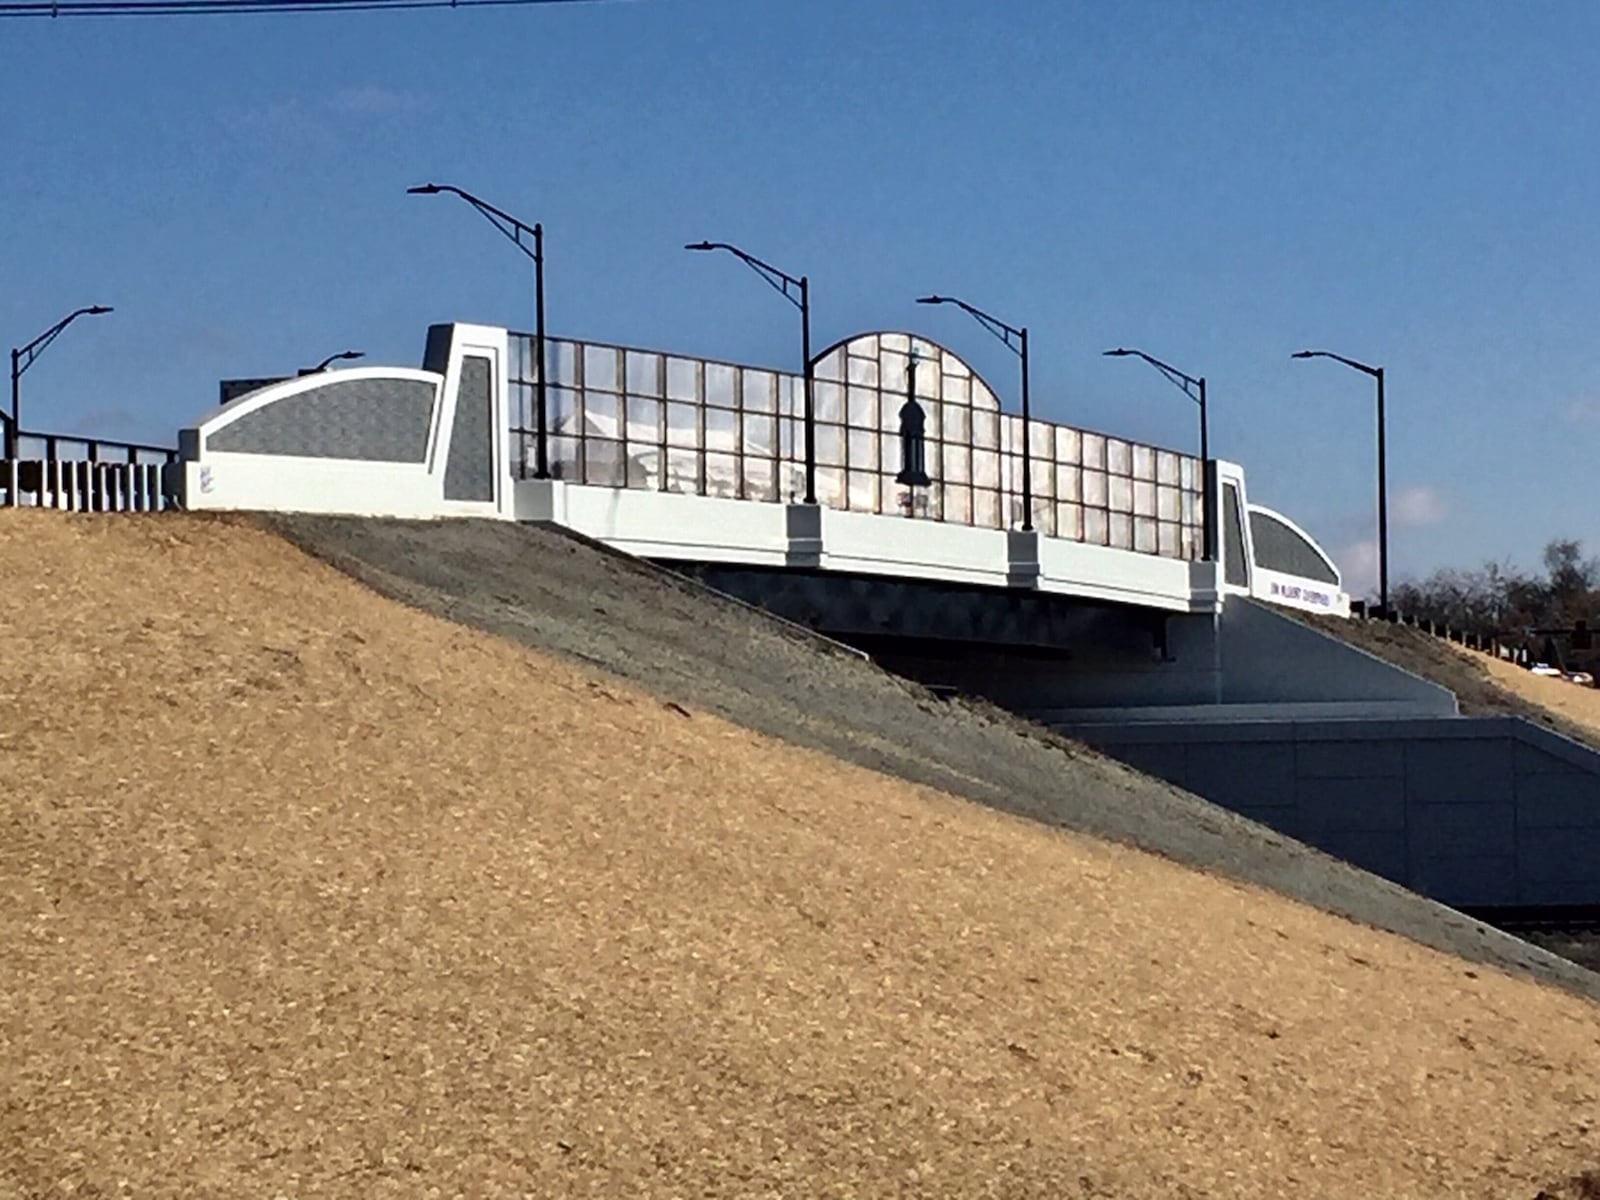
[1058,717,1600,907]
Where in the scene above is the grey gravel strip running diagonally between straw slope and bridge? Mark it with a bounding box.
[258,514,1600,998]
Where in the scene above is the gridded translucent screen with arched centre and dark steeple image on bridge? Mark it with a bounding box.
[510,333,1202,558]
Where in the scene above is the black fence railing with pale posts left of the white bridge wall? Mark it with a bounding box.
[0,430,179,512]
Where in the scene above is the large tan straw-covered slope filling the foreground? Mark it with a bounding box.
[0,512,1600,1200]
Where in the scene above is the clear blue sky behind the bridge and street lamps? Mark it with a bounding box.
[0,0,1600,584]
